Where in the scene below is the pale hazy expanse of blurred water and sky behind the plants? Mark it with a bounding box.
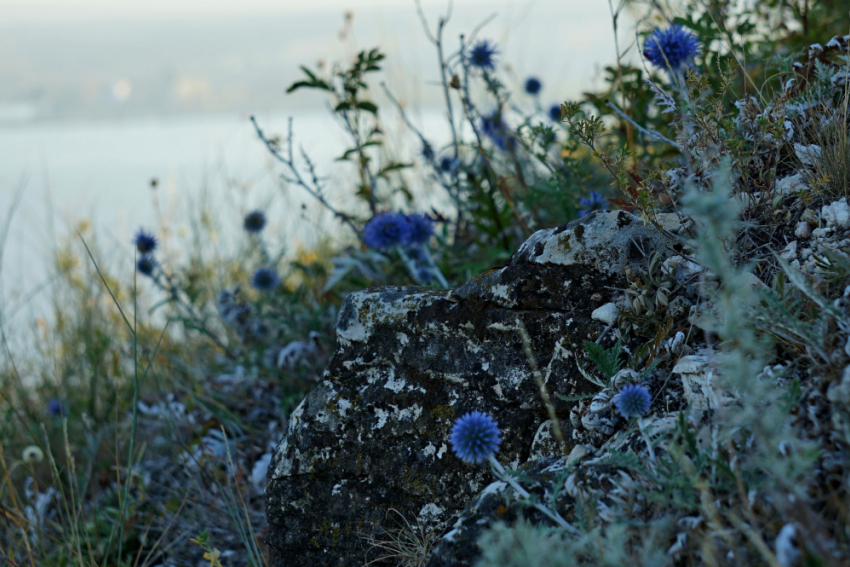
[0,0,614,348]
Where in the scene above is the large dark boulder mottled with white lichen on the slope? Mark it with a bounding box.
[266,211,675,567]
